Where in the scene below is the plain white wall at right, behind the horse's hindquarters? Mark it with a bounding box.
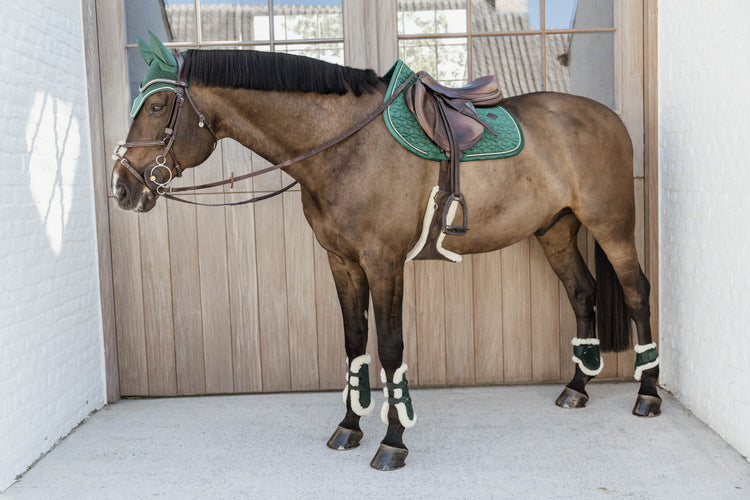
[658,0,750,457]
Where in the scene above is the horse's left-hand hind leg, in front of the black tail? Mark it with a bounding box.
[536,213,602,408]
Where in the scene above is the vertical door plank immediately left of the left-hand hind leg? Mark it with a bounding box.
[529,238,560,381]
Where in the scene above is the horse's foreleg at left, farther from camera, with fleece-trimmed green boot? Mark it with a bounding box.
[328,252,374,450]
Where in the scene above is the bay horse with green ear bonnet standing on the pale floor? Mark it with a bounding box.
[112,36,661,470]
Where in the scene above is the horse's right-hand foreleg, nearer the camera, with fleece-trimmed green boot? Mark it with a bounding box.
[368,261,416,470]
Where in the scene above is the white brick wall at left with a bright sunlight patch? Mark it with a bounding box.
[0,0,106,491]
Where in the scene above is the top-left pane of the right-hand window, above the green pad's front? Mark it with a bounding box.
[398,0,466,35]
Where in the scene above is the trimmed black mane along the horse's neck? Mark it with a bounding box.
[185,50,382,95]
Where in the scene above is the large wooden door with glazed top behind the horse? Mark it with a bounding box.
[96,0,656,396]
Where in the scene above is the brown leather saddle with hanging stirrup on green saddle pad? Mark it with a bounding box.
[404,71,503,236]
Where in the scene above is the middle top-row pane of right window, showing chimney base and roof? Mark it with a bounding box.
[471,0,541,33]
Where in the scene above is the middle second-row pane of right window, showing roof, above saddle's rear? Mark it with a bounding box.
[471,35,542,97]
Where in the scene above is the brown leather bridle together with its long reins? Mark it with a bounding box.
[113,54,416,207]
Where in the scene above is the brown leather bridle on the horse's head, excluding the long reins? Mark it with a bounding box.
[112,54,218,195]
